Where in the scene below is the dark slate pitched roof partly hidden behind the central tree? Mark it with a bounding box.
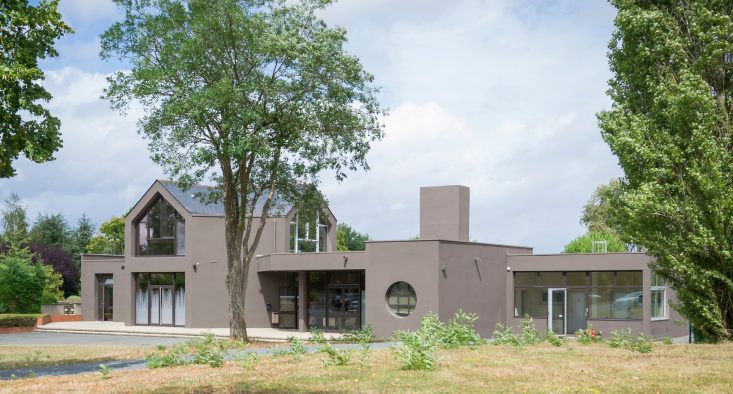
[159,180,293,217]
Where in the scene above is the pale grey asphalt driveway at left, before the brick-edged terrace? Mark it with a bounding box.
[0,331,188,346]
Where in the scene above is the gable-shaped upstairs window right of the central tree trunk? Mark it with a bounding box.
[290,210,328,253]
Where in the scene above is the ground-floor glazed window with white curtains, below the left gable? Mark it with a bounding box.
[135,272,186,326]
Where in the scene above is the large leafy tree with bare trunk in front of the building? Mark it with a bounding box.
[101,0,383,339]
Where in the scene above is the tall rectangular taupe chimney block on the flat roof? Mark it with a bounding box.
[420,186,471,242]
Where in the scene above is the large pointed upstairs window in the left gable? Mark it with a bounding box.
[134,197,185,256]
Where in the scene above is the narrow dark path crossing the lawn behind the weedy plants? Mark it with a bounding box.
[0,342,397,380]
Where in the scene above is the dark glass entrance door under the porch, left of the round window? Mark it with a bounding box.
[326,285,362,331]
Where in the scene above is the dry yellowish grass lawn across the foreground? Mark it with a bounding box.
[0,342,733,393]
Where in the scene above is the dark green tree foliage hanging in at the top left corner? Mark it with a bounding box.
[0,0,72,178]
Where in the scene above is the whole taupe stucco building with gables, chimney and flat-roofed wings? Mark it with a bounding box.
[81,181,687,337]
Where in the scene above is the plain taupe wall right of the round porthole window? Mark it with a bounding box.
[439,241,532,338]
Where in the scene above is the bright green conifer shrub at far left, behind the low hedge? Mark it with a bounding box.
[0,248,46,313]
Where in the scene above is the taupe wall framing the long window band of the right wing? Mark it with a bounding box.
[505,253,687,337]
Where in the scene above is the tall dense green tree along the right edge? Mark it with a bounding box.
[599,0,733,340]
